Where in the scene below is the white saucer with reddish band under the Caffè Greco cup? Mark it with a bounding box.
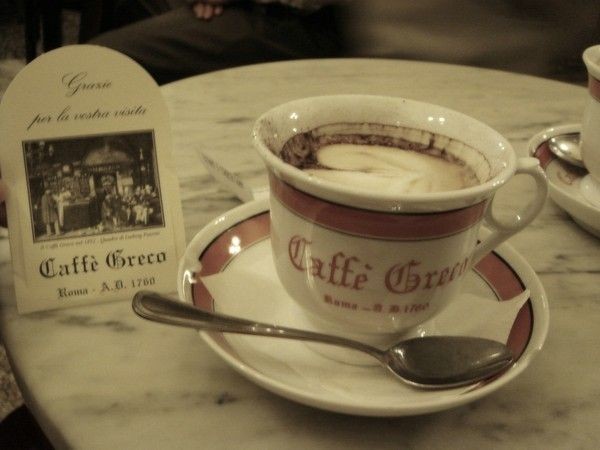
[179,200,549,416]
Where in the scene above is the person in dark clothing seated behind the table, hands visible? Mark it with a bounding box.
[89,0,343,84]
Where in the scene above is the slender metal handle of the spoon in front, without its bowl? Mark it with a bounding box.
[132,291,383,360]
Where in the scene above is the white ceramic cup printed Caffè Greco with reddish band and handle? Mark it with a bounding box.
[253,95,547,342]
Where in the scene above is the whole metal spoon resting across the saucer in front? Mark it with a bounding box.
[132,291,513,389]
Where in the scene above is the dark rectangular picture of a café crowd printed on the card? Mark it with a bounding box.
[23,131,164,242]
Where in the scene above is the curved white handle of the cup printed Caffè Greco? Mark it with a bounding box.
[470,157,548,267]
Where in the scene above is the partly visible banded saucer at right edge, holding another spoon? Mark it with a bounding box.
[528,124,600,237]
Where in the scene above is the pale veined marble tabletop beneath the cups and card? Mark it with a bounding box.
[0,60,600,449]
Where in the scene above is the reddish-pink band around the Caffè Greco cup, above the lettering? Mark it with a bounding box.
[269,174,487,240]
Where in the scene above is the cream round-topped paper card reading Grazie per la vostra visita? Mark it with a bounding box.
[0,45,185,313]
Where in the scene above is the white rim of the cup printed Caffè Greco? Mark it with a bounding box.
[252,94,517,212]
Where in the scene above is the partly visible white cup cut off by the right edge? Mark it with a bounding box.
[581,45,600,208]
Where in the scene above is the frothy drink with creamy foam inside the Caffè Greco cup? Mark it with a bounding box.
[280,124,480,194]
